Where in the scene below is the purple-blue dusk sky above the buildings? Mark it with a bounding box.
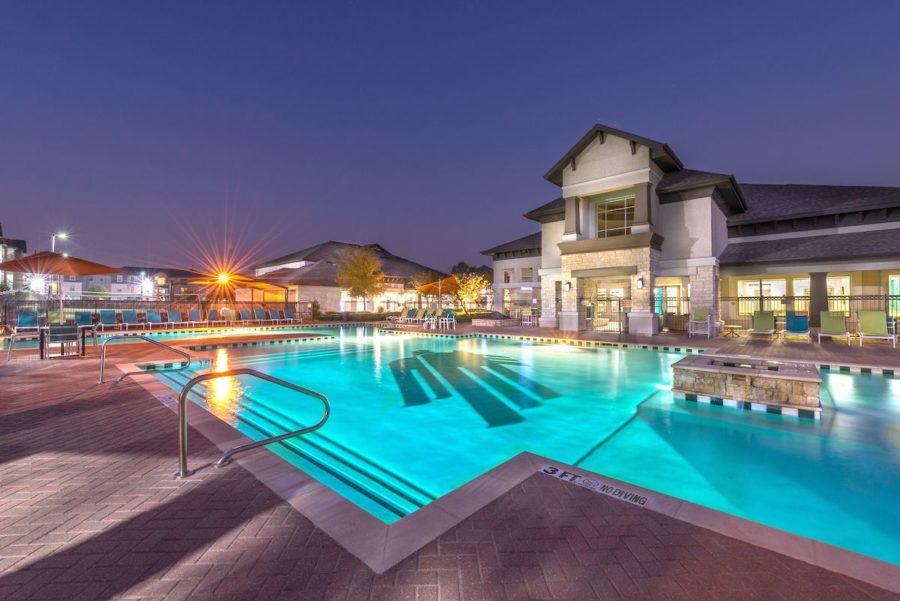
[0,0,900,270]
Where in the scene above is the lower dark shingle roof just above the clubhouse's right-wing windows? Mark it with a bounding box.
[719,229,900,265]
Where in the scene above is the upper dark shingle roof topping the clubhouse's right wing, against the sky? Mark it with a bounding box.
[728,184,900,225]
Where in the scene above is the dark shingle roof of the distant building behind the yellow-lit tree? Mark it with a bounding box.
[254,240,446,286]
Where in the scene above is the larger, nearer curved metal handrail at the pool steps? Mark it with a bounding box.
[175,367,331,478]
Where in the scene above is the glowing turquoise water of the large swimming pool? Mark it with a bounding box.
[157,328,900,563]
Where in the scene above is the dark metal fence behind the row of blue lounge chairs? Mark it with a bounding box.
[0,299,309,326]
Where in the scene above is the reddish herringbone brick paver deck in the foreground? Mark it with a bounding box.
[0,348,900,601]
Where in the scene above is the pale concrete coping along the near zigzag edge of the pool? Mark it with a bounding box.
[116,355,900,593]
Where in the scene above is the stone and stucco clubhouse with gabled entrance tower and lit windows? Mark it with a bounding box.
[484,124,900,334]
